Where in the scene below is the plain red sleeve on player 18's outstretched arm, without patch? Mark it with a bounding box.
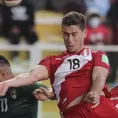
[39,56,52,77]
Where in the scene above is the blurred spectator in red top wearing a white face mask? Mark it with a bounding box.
[85,9,111,45]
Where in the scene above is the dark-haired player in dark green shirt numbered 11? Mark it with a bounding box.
[0,55,48,118]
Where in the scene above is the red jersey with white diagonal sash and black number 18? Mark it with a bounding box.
[40,48,109,111]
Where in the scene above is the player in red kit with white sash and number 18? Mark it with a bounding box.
[0,12,118,118]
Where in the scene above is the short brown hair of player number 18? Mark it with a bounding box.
[61,12,86,30]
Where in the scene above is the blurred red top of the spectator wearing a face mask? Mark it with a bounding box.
[84,25,110,44]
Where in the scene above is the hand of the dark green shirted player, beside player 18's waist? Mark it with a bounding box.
[33,87,54,101]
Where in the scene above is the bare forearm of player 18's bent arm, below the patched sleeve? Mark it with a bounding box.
[90,77,106,94]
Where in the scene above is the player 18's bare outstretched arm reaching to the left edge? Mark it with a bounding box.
[0,65,49,95]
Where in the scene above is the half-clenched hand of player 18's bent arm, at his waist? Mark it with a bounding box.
[83,91,100,108]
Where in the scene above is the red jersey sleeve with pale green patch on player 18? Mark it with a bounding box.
[94,51,110,70]
